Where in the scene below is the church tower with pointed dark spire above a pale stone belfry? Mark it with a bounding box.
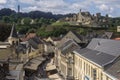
[8,24,19,45]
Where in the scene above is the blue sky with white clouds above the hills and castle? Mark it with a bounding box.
[0,0,120,17]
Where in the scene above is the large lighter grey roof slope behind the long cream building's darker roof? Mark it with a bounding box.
[87,38,120,57]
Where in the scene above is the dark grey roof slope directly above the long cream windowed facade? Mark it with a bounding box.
[76,48,115,66]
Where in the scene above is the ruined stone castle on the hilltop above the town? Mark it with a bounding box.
[59,10,109,27]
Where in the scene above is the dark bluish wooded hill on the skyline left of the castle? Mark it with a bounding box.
[0,8,72,20]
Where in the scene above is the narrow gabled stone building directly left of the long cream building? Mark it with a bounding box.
[58,39,80,80]
